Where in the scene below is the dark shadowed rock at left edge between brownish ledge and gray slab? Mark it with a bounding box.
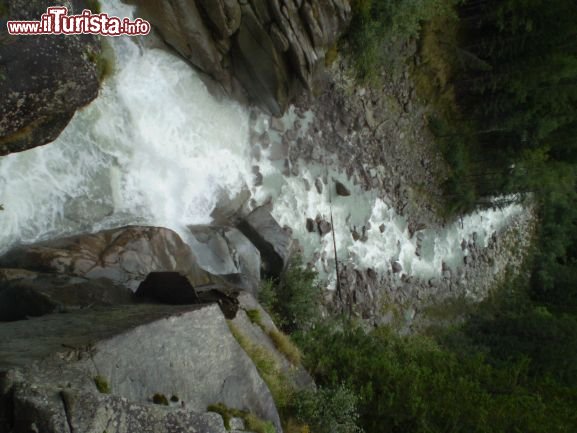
[0,272,133,322]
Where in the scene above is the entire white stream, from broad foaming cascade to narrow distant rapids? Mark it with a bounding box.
[0,1,523,286]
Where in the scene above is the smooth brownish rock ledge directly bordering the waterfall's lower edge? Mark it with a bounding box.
[0,226,216,291]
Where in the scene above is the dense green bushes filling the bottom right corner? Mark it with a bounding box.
[301,318,577,433]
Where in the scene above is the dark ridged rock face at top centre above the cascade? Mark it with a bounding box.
[131,0,351,116]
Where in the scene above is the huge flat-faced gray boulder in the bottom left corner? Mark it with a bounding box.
[0,305,282,433]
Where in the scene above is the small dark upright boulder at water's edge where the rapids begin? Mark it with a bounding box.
[238,207,292,278]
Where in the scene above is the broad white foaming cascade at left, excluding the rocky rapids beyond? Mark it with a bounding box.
[0,2,250,250]
